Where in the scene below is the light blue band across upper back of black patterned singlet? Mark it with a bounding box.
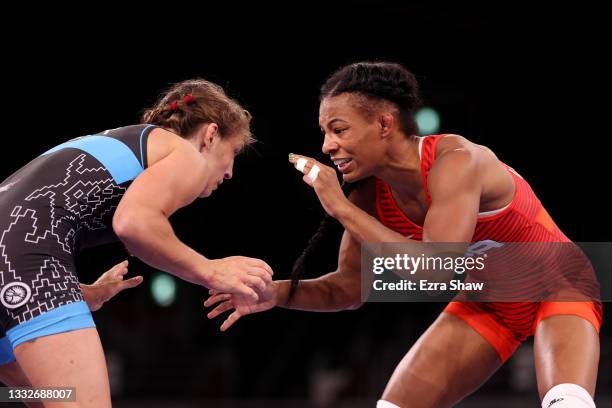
[42,135,144,184]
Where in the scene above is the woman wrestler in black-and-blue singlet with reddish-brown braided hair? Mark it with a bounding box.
[0,80,272,407]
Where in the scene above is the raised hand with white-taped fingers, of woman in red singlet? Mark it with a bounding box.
[289,153,349,218]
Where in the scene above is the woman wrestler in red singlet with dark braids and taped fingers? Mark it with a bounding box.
[206,63,602,408]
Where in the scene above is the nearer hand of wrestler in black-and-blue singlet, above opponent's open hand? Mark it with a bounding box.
[204,256,274,302]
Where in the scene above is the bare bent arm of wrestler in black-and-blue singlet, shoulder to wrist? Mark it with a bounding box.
[113,135,207,284]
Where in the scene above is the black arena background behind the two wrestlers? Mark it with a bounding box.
[0,1,612,407]
